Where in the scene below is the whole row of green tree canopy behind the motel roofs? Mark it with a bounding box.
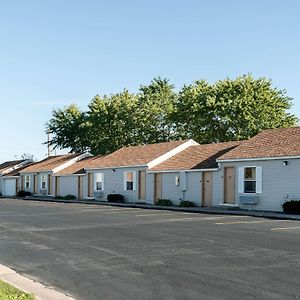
[46,75,298,154]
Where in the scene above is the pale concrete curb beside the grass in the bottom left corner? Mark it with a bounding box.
[0,264,75,300]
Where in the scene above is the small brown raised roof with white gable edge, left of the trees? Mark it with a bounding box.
[21,153,80,173]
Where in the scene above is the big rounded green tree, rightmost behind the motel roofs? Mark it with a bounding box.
[172,75,297,143]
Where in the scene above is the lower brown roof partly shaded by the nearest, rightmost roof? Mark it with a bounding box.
[151,142,241,171]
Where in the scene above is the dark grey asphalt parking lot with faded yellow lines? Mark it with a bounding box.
[0,199,300,300]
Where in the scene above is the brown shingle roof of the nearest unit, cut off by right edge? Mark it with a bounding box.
[219,127,300,160]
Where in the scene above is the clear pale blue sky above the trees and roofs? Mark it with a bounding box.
[0,0,300,161]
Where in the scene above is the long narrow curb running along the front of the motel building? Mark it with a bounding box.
[1,197,300,221]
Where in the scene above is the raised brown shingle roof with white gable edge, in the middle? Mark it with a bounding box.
[89,140,187,168]
